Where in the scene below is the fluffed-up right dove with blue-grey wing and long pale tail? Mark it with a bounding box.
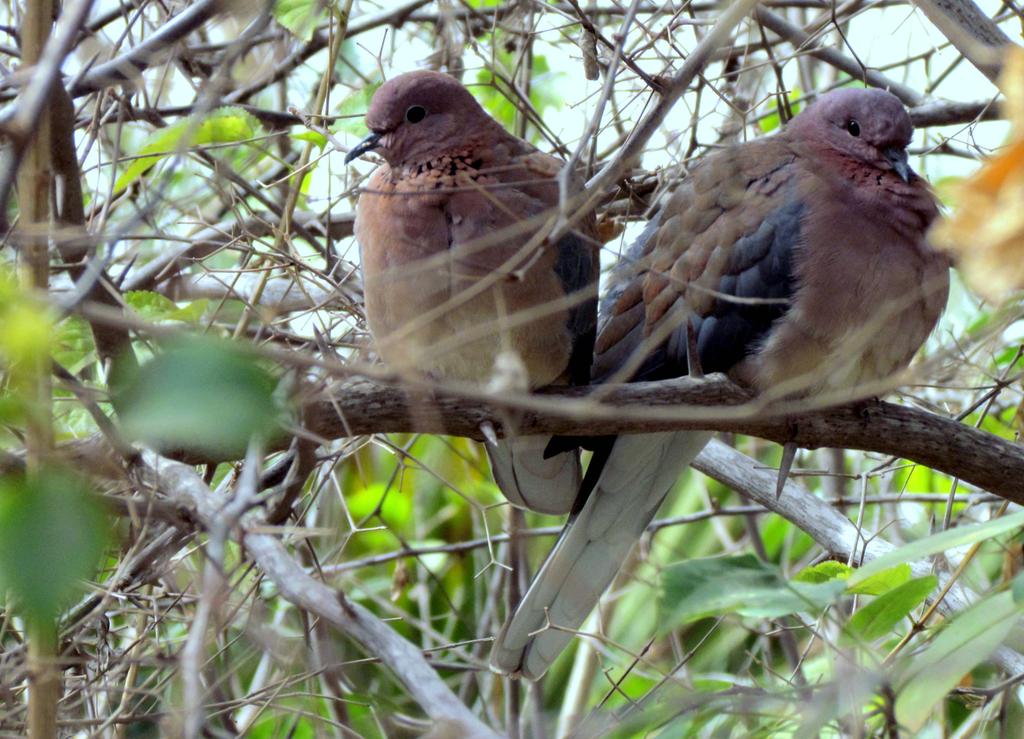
[490,88,949,680]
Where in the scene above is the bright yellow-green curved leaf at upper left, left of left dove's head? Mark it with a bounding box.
[114,106,263,193]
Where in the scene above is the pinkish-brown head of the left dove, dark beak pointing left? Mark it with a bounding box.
[345,71,498,167]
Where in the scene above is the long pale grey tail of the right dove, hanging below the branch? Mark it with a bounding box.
[490,431,711,680]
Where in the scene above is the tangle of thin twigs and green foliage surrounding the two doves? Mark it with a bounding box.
[0,0,1024,738]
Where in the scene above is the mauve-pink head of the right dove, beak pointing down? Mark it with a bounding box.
[786,87,915,182]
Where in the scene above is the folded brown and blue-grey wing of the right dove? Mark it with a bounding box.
[594,139,804,380]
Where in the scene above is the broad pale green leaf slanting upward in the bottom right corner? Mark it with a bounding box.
[896,593,1020,732]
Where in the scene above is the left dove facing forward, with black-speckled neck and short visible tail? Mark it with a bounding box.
[345,71,600,514]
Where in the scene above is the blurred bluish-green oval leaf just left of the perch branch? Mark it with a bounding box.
[111,339,278,459]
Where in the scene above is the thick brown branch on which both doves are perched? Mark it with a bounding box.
[306,376,1024,504]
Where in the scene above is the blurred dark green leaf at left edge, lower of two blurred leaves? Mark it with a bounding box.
[0,468,110,620]
